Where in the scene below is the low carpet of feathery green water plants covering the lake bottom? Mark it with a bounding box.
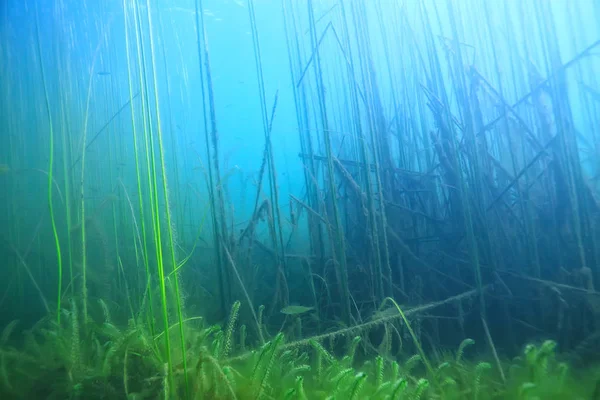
[0,298,600,400]
